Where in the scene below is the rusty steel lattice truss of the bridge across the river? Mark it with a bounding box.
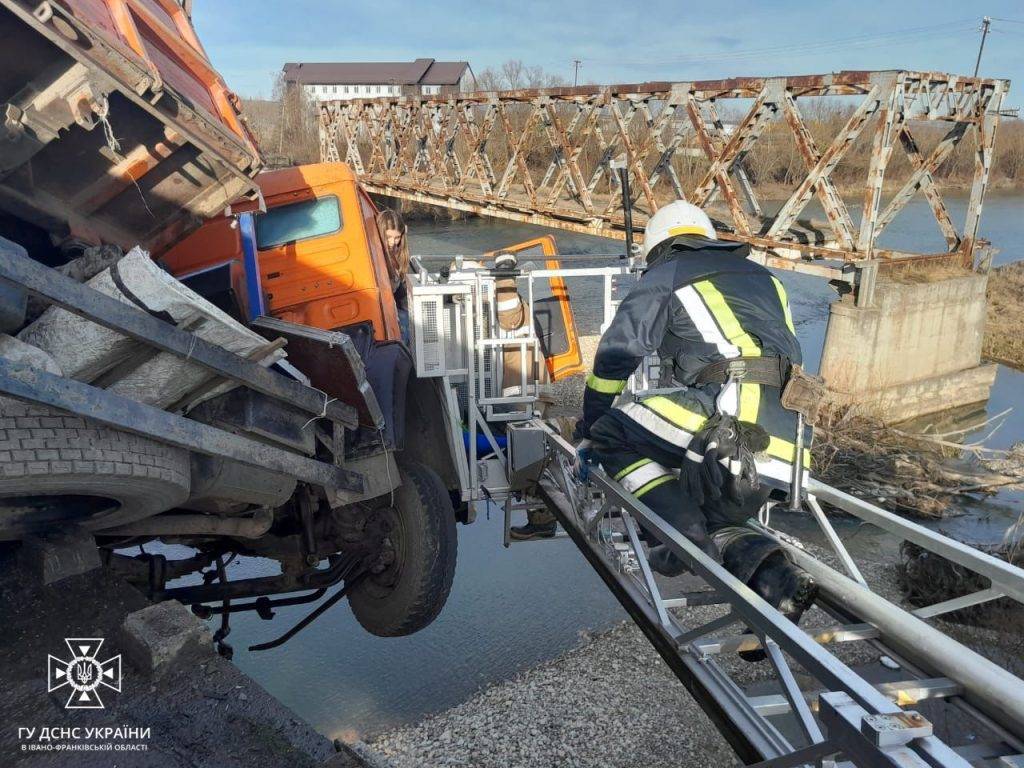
[319,71,1009,301]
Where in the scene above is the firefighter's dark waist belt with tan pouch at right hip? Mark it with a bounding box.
[694,355,826,426]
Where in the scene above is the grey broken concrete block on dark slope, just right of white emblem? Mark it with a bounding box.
[121,600,212,676]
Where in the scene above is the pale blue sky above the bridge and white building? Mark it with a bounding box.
[193,0,1024,104]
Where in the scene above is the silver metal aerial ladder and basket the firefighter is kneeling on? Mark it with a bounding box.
[413,262,1024,768]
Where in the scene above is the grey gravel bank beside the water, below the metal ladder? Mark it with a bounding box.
[369,553,899,768]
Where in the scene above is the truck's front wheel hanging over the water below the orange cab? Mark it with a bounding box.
[348,462,458,637]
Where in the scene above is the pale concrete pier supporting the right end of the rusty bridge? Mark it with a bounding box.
[820,273,996,422]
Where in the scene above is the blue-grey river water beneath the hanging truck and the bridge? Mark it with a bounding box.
[214,195,1024,738]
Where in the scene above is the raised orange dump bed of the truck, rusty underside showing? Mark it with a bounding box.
[0,0,261,259]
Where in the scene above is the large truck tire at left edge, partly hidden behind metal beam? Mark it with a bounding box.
[0,397,189,541]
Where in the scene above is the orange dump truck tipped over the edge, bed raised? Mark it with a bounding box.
[0,0,467,652]
